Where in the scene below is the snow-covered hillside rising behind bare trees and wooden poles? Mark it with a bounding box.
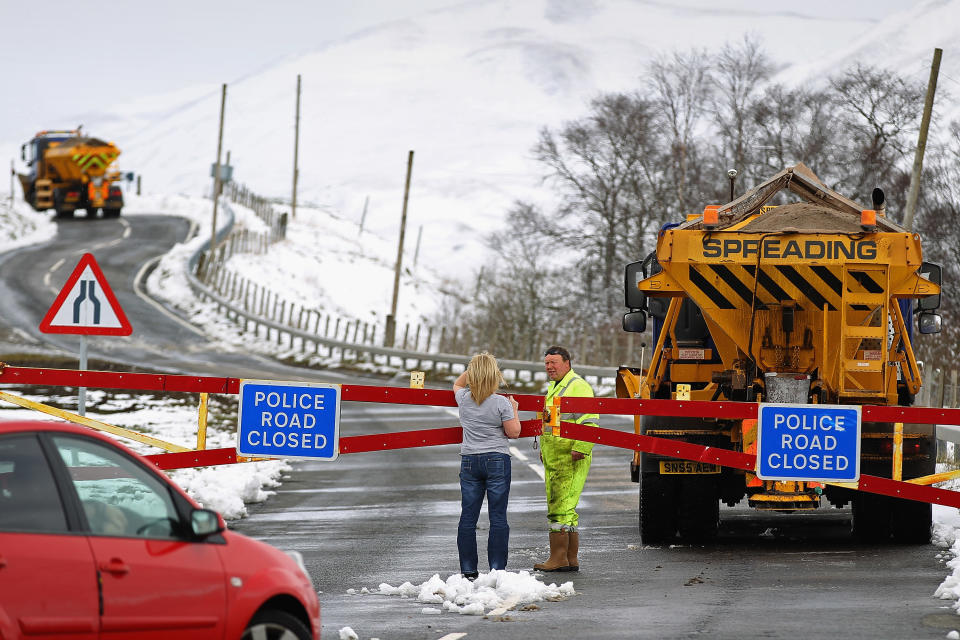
[7,0,960,284]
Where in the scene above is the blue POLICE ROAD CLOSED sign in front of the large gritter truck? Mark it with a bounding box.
[757,403,860,482]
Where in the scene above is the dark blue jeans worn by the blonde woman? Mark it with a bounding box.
[457,453,510,573]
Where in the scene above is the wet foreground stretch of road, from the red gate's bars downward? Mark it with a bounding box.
[233,403,960,640]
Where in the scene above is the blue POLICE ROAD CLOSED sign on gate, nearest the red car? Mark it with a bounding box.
[237,380,340,460]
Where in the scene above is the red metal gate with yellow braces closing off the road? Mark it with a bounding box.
[0,366,960,508]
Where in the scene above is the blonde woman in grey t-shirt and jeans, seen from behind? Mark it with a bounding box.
[453,352,520,580]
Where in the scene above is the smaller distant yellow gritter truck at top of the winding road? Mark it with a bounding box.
[18,129,123,218]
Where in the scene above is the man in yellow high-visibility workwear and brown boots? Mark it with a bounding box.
[533,347,600,571]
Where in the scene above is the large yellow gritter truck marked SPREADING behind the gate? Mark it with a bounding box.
[617,164,940,543]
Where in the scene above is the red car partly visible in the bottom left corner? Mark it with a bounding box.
[0,421,320,640]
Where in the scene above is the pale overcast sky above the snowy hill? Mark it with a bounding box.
[0,0,919,142]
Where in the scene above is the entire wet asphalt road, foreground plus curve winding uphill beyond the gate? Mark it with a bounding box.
[0,215,960,640]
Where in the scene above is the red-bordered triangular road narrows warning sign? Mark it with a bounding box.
[40,253,133,336]
